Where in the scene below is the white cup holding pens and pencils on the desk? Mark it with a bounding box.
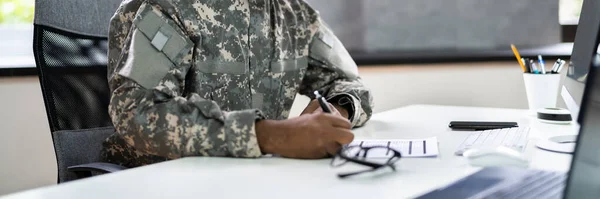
[523,73,560,112]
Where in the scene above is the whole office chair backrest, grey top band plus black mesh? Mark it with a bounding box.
[33,0,121,132]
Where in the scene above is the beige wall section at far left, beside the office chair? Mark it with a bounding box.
[0,76,56,195]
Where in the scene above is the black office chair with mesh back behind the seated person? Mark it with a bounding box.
[33,0,125,183]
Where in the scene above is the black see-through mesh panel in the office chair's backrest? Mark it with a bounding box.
[34,25,111,132]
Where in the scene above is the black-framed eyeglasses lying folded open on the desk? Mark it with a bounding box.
[331,146,402,178]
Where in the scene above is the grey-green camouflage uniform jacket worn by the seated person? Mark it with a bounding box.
[102,0,372,167]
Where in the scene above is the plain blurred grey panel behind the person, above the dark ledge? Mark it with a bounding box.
[307,0,560,50]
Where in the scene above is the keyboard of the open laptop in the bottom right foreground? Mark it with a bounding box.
[472,170,567,199]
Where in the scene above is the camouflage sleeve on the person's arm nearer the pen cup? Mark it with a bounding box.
[300,15,373,127]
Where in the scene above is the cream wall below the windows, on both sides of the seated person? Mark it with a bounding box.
[0,62,540,195]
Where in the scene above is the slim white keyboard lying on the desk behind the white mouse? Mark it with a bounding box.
[454,127,529,156]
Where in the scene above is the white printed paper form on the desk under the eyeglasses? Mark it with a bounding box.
[348,137,439,158]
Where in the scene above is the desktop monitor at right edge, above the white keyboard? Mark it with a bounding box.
[561,0,600,122]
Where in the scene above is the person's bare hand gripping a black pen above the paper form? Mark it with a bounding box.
[255,91,354,159]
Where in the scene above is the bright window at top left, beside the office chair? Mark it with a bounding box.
[0,0,35,68]
